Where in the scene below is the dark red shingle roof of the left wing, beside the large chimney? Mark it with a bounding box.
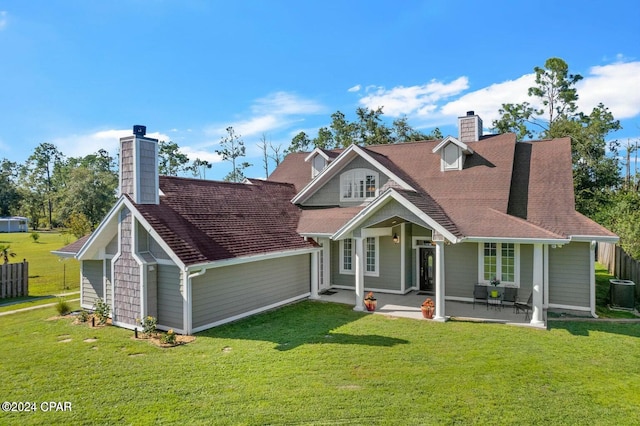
[136,176,312,265]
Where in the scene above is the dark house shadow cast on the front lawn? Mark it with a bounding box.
[197,301,409,351]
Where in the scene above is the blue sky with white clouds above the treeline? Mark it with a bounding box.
[0,0,640,179]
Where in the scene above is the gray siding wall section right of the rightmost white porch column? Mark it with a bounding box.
[549,243,593,308]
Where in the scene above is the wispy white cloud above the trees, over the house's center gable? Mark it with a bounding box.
[360,77,469,117]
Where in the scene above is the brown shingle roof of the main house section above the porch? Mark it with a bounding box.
[269,134,615,239]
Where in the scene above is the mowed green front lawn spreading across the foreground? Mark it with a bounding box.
[0,301,640,425]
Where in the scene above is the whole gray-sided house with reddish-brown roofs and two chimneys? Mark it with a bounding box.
[58,112,618,334]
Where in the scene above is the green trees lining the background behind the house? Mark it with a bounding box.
[0,58,640,258]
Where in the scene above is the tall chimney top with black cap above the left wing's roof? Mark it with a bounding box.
[119,125,160,204]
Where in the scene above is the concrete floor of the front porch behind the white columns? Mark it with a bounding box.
[319,288,546,328]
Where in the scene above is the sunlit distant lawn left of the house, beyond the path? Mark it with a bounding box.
[0,232,80,296]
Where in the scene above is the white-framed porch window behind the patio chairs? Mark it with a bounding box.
[480,243,520,285]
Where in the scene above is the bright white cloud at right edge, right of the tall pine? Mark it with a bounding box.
[576,62,640,120]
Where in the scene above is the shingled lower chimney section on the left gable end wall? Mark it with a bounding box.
[113,208,141,326]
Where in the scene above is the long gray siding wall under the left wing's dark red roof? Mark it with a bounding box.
[191,255,311,329]
